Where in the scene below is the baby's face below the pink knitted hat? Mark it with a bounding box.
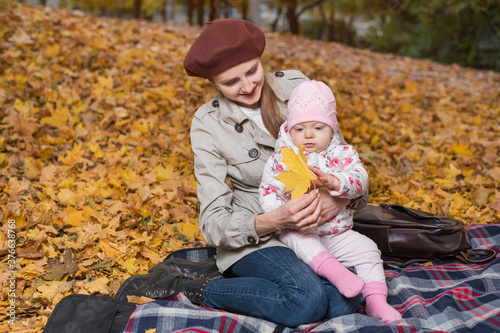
[290,121,334,153]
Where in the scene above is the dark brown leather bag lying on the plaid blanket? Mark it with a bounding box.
[353,204,495,267]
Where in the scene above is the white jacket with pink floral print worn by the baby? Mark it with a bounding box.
[259,126,368,235]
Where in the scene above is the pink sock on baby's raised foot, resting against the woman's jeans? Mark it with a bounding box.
[309,251,365,297]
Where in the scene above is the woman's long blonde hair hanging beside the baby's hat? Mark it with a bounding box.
[260,72,286,139]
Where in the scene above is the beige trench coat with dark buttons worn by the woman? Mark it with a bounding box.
[191,71,367,272]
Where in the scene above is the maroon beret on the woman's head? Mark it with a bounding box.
[184,19,266,79]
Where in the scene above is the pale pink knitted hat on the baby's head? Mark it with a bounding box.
[286,80,337,133]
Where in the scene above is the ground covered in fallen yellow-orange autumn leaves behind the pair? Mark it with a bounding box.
[0,1,500,332]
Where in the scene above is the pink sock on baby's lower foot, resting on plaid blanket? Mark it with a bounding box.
[361,281,402,323]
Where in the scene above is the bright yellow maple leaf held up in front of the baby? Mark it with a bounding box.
[276,145,316,199]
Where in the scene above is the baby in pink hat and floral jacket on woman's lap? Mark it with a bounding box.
[259,81,402,322]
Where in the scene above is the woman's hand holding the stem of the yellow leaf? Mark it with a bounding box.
[255,190,322,237]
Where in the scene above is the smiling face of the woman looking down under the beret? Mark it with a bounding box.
[210,58,264,109]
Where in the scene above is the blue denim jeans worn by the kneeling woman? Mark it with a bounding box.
[204,246,361,327]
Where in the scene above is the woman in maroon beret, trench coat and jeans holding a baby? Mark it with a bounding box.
[117,19,367,327]
